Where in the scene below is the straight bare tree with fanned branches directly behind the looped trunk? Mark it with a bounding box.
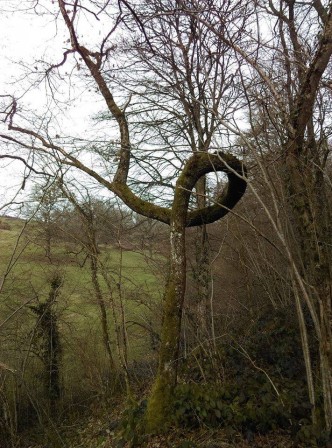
[113,0,248,336]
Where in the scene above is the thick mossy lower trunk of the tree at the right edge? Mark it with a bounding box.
[286,149,332,433]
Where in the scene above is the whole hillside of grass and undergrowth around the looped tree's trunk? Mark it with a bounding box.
[0,217,318,448]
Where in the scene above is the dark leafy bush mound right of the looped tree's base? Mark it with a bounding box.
[174,308,316,433]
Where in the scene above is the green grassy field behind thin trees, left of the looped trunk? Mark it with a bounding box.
[0,217,164,387]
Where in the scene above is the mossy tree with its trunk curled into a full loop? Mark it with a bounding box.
[0,0,246,431]
